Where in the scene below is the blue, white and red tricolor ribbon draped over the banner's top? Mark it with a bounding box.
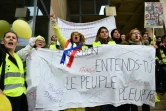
[60,40,82,68]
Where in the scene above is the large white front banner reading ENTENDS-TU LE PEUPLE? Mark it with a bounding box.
[27,45,155,111]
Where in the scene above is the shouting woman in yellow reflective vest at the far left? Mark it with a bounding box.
[0,32,28,111]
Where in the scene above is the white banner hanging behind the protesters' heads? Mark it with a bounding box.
[58,16,116,44]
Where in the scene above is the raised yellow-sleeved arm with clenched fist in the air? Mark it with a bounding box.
[50,13,67,49]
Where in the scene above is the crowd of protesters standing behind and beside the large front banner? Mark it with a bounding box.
[0,13,166,111]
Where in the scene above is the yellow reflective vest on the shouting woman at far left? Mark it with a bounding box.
[0,53,26,97]
